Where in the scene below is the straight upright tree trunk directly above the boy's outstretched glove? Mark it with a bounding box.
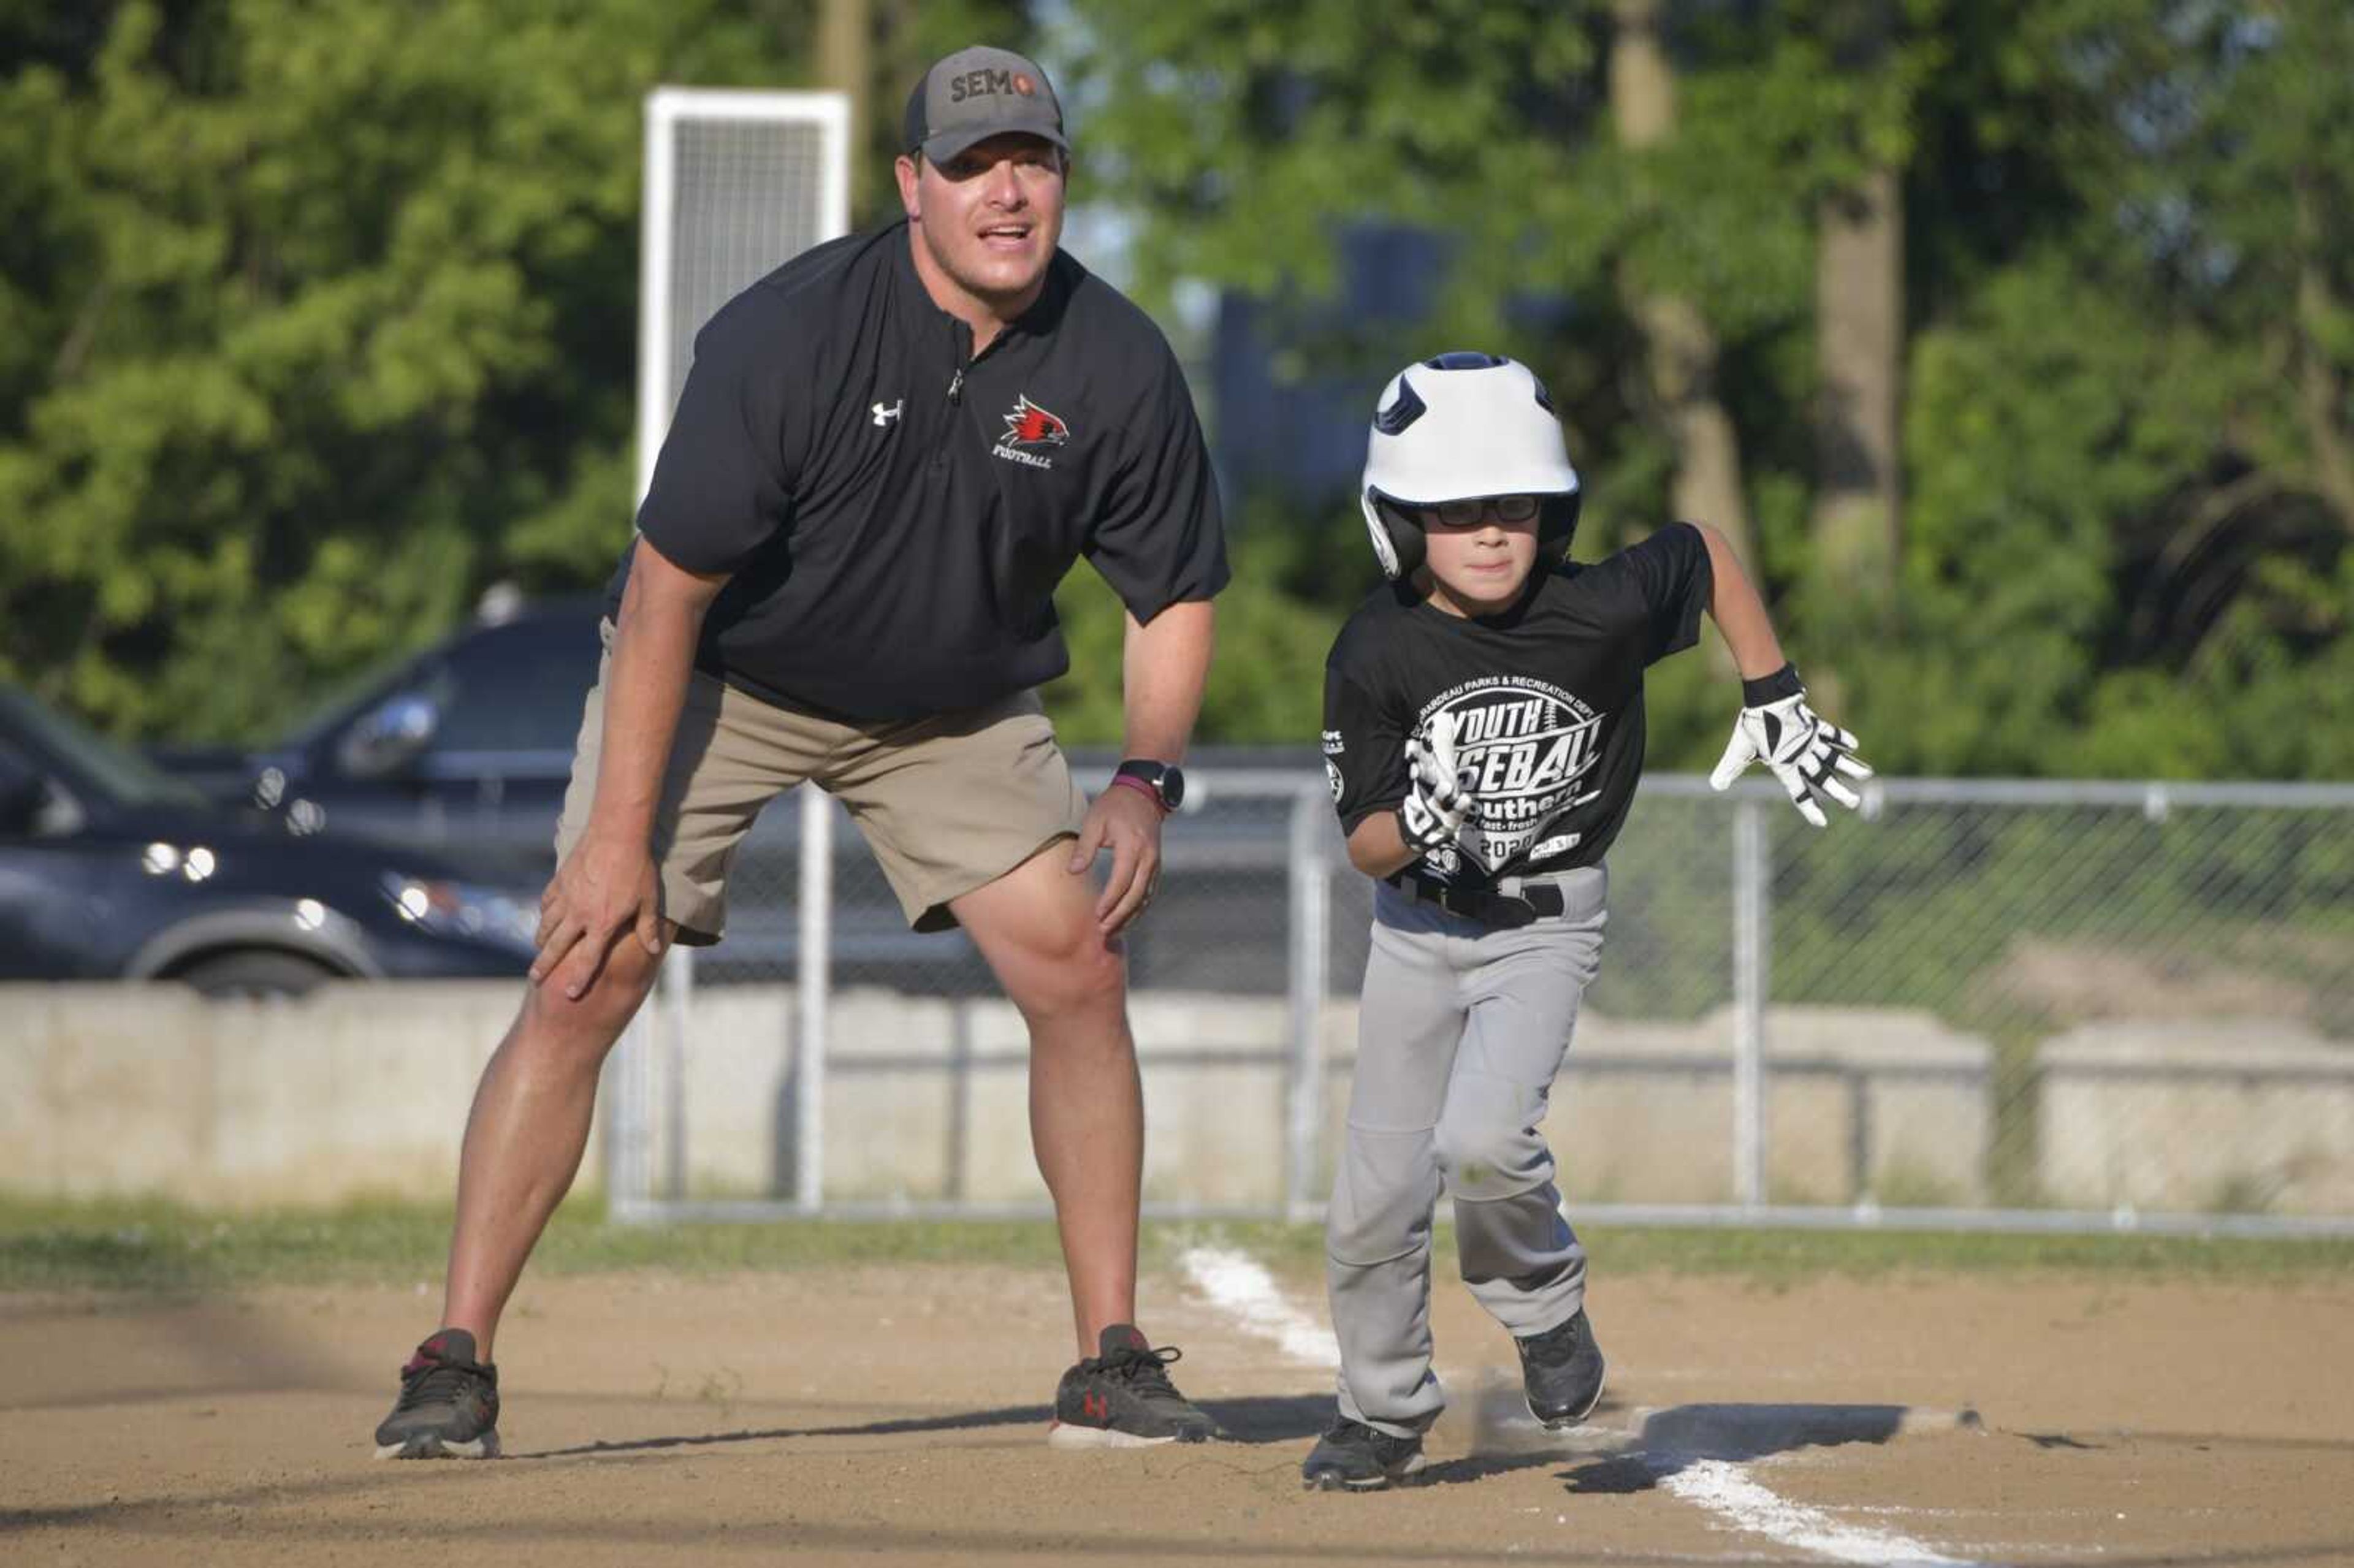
[1813,167,1905,614]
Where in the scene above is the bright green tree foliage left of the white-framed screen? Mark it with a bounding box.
[0,0,828,737]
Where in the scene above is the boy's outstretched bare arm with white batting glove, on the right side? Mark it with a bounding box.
[1695,523,1872,826]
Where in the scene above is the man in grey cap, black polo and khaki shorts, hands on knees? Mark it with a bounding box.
[376,47,1227,1457]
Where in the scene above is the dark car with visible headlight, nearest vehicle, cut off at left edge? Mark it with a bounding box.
[0,688,539,994]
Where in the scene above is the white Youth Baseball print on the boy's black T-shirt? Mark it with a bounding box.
[1420,676,1603,873]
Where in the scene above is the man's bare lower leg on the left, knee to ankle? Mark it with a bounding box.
[443,923,678,1361]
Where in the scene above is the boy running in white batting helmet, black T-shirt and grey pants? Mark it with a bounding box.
[1302,353,1872,1490]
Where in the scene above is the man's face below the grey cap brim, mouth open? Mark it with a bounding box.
[899,132,1064,306]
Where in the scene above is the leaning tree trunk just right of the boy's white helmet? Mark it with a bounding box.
[1610,0,1756,572]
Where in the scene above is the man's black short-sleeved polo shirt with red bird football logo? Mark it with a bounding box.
[610,221,1227,720]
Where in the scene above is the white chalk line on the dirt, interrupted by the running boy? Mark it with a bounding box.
[1179,1248,1975,1568]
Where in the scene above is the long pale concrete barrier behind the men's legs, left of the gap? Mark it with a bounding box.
[0,982,1989,1206]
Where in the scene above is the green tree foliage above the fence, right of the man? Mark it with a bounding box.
[1073,0,2354,777]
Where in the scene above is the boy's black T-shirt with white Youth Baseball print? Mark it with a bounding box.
[1323,523,1714,892]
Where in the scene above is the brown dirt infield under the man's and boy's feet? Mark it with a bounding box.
[0,1260,2354,1568]
